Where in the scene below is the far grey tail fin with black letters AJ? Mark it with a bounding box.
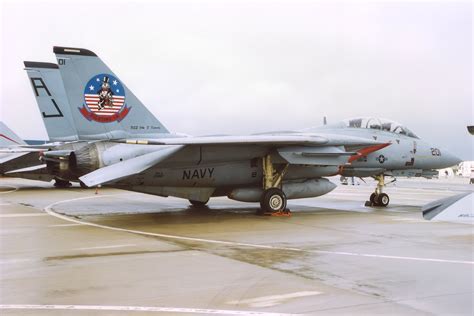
[24,61,78,141]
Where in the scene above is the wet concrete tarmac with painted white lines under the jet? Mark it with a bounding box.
[0,178,474,315]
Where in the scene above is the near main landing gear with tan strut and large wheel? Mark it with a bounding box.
[257,155,291,216]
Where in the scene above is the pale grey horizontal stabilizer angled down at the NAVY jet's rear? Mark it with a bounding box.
[79,146,182,187]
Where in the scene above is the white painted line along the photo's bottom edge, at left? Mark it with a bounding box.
[0,304,296,316]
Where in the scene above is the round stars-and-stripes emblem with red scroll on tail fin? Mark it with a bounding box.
[79,74,131,123]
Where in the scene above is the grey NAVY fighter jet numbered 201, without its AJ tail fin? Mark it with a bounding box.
[21,47,457,212]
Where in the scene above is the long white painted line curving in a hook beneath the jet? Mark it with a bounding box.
[44,195,474,265]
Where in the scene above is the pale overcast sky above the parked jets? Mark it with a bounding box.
[0,0,474,160]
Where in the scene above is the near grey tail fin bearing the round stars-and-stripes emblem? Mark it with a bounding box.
[54,47,169,139]
